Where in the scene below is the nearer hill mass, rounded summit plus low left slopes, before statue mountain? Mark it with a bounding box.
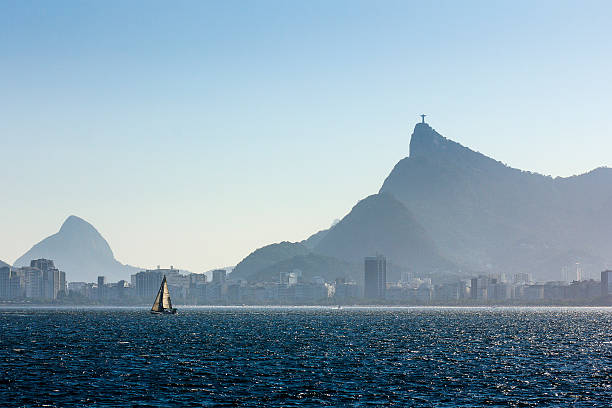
[231,194,457,282]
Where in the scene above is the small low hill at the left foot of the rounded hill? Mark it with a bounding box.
[230,241,310,280]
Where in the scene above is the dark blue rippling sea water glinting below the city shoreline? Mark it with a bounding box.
[0,307,612,407]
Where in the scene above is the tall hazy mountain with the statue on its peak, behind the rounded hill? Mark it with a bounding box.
[380,123,612,279]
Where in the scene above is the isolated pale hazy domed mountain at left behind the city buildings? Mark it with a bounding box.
[15,215,139,282]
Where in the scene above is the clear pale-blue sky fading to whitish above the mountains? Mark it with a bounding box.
[0,0,612,272]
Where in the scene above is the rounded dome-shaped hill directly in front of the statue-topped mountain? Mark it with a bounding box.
[314,193,454,272]
